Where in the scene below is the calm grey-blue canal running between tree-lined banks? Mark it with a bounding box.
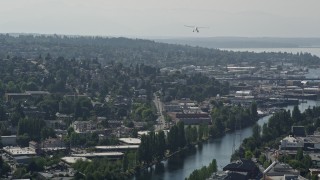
[135,100,320,180]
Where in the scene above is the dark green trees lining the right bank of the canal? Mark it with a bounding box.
[231,105,320,179]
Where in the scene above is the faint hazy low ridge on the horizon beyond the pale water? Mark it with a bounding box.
[154,37,320,48]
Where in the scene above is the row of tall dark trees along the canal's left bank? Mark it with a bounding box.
[129,102,259,179]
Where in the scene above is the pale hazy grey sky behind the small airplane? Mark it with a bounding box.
[0,0,320,37]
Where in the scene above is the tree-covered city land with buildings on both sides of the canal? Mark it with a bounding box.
[0,34,320,180]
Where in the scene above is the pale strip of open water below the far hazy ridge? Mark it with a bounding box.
[220,47,320,57]
